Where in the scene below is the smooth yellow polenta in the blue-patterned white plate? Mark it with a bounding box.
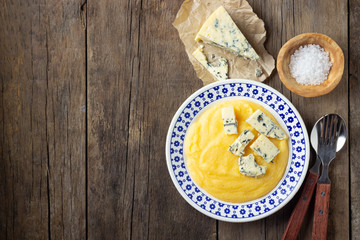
[184,100,289,203]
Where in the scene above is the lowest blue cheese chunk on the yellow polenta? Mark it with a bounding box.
[239,154,266,178]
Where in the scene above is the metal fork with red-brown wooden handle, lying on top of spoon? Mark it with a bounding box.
[312,114,342,239]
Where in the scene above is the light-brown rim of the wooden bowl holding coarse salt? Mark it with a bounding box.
[276,33,345,97]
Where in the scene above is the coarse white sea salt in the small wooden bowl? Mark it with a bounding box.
[289,44,332,85]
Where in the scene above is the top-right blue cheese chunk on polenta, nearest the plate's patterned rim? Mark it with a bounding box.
[246,109,287,140]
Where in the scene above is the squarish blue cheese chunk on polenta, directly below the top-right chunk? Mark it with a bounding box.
[250,135,280,163]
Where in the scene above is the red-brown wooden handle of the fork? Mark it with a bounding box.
[312,183,330,240]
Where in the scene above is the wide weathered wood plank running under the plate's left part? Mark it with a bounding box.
[87,1,216,239]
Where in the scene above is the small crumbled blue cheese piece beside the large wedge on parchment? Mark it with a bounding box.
[193,47,229,80]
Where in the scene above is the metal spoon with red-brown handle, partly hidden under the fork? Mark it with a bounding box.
[281,113,346,240]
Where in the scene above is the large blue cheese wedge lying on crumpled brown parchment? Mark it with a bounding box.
[195,6,260,60]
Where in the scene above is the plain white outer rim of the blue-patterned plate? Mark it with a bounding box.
[165,79,310,223]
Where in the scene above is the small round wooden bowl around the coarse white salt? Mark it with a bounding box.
[276,33,344,97]
